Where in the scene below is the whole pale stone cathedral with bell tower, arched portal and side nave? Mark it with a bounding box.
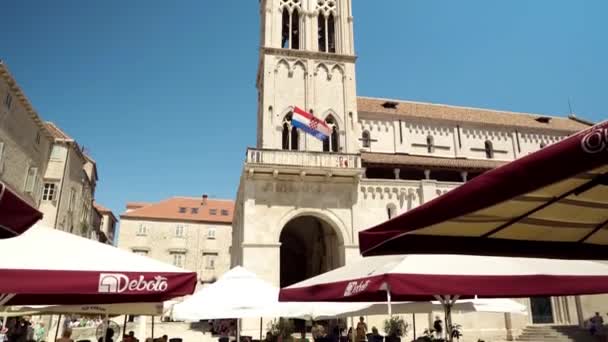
[231,0,597,339]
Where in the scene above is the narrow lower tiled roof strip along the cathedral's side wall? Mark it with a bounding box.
[361,152,506,171]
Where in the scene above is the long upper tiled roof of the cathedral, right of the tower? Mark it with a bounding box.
[357,97,589,132]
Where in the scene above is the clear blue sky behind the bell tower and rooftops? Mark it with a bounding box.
[0,0,608,218]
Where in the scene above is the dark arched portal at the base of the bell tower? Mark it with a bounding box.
[280,216,344,287]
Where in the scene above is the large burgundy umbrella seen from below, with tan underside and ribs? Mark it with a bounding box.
[359,121,608,259]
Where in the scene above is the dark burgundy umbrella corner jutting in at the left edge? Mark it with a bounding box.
[0,182,42,239]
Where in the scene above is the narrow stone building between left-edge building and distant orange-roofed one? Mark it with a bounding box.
[40,122,98,237]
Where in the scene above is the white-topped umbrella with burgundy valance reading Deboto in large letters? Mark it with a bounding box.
[0,224,196,306]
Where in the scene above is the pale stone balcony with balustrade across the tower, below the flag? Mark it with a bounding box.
[245,148,363,177]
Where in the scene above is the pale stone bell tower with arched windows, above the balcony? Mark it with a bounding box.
[257,0,358,153]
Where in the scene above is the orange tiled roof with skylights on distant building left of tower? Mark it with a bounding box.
[120,197,234,224]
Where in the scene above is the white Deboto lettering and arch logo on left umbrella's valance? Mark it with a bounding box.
[98,273,169,293]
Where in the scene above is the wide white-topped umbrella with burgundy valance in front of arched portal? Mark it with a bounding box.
[279,255,608,337]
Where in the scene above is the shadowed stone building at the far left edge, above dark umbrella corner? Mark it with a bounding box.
[0,60,53,207]
